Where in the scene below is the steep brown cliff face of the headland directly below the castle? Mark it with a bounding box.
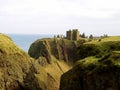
[28,39,76,63]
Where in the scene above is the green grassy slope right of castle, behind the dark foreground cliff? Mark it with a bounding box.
[76,36,120,60]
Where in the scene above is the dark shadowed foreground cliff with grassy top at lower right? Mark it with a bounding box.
[60,52,120,90]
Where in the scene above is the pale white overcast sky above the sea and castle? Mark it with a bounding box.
[0,0,120,35]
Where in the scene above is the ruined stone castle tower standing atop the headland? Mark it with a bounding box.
[66,29,80,40]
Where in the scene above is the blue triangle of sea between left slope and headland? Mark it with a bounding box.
[8,34,52,52]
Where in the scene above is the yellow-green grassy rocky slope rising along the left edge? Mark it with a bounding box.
[0,34,41,90]
